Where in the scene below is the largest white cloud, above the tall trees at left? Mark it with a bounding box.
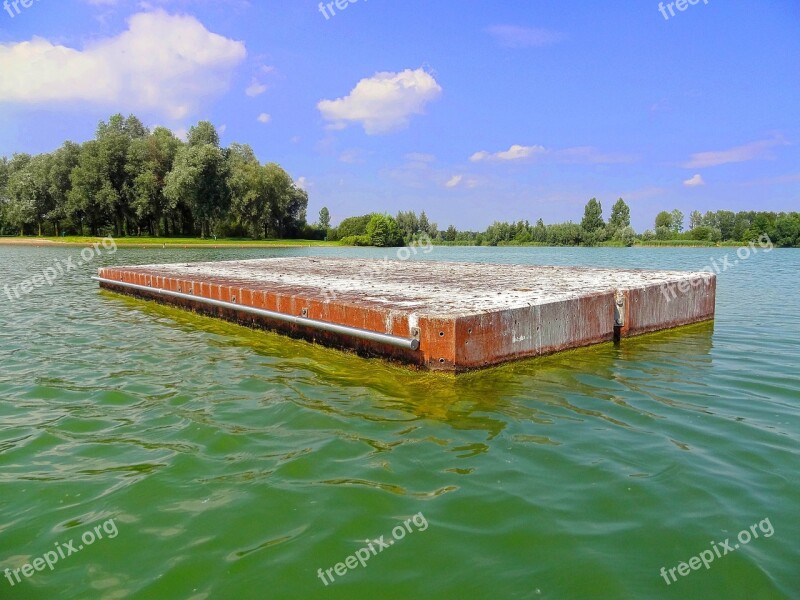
[0,10,247,119]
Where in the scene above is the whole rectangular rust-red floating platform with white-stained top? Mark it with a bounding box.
[95,257,716,372]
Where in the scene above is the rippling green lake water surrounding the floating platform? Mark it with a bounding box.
[0,246,800,600]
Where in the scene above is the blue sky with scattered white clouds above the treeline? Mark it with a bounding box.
[0,0,800,231]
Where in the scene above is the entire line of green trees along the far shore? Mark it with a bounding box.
[0,115,800,247]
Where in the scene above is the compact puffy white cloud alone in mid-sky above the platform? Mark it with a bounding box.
[317,69,442,135]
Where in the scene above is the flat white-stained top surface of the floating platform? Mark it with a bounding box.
[110,257,713,315]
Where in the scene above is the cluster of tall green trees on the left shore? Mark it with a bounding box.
[0,115,310,238]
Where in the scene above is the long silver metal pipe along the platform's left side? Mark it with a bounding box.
[92,277,419,350]
